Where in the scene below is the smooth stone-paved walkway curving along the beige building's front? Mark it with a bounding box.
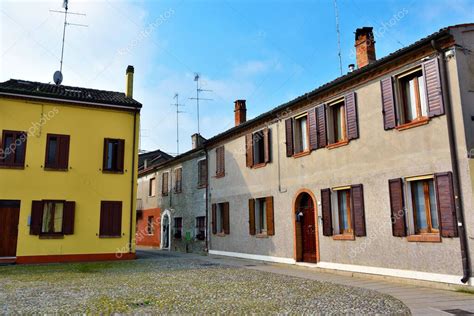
[137,250,474,315]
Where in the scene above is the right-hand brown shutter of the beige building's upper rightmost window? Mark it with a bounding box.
[423,58,444,117]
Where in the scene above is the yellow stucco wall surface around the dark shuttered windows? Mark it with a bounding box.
[0,98,139,257]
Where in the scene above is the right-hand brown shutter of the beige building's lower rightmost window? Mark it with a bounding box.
[435,172,458,237]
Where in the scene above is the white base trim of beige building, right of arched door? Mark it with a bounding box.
[315,262,474,286]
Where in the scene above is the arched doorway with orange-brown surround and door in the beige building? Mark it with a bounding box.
[294,191,319,263]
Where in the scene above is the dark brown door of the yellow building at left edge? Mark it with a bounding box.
[0,201,20,258]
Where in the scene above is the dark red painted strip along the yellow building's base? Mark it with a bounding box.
[16,253,136,264]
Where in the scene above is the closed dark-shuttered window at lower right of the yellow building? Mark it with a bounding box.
[99,201,122,237]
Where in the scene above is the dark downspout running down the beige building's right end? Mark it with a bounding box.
[431,40,471,283]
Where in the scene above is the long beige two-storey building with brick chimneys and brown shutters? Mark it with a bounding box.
[205,24,474,285]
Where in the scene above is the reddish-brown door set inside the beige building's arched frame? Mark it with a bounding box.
[297,194,316,263]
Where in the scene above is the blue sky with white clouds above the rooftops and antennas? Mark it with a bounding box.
[0,0,474,155]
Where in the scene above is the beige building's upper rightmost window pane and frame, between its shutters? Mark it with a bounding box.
[397,68,428,125]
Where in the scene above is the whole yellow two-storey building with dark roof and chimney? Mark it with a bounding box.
[0,66,141,263]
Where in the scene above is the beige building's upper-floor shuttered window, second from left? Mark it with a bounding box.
[245,127,271,168]
